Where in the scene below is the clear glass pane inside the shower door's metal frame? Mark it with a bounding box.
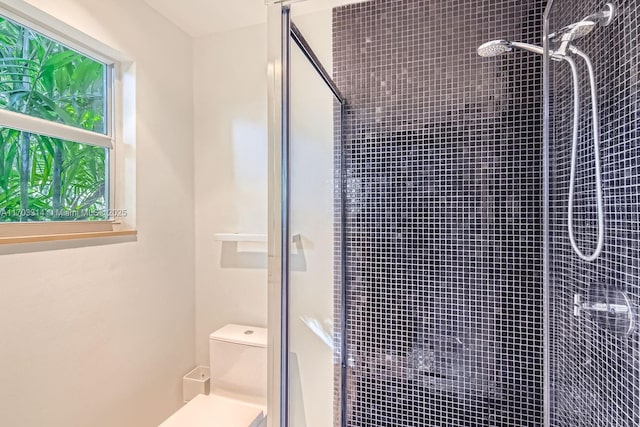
[288,21,335,427]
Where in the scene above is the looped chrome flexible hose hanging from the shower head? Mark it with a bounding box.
[563,46,604,261]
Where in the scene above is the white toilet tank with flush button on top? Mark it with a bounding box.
[209,325,267,402]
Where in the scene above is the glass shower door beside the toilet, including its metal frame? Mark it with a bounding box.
[269,5,350,427]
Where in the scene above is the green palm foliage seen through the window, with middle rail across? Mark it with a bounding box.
[0,17,111,223]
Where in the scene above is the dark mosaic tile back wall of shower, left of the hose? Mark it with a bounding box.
[333,0,546,427]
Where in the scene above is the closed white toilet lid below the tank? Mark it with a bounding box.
[160,394,264,427]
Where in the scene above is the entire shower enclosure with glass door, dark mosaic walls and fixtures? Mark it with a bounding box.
[268,0,640,427]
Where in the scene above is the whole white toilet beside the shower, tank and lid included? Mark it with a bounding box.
[160,325,267,427]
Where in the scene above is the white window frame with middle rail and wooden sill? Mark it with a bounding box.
[0,0,136,244]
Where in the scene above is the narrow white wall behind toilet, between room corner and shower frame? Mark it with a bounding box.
[194,25,267,365]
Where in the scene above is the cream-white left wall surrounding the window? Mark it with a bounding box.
[0,0,195,427]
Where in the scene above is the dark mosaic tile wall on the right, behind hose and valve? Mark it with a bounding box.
[550,0,640,427]
